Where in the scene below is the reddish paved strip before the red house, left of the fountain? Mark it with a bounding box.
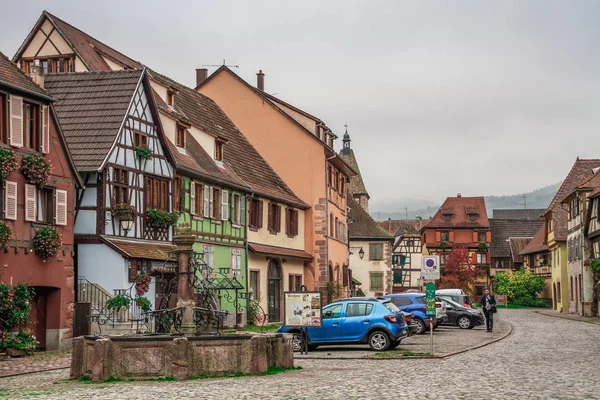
[0,351,71,377]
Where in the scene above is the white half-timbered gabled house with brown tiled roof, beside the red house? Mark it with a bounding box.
[46,70,174,316]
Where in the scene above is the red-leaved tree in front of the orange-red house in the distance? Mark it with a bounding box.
[440,247,487,293]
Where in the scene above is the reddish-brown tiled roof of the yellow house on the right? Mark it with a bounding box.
[544,158,600,241]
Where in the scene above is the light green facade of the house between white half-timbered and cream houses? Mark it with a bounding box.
[178,176,247,320]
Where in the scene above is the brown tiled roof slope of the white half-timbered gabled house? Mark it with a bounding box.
[45,70,143,171]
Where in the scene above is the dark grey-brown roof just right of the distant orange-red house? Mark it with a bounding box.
[490,218,544,257]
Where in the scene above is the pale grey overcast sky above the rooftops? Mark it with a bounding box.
[0,0,600,208]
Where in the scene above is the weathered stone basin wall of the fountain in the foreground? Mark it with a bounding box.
[71,333,294,382]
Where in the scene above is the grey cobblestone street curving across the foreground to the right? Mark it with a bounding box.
[0,310,600,400]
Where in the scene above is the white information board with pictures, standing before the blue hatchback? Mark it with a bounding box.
[283,292,322,328]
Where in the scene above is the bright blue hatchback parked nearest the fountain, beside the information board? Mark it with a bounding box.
[278,297,408,351]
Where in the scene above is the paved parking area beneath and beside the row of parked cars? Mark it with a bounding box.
[294,310,512,360]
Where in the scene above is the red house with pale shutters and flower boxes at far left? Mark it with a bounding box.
[0,53,82,349]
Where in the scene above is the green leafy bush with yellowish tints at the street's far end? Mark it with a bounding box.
[494,269,546,301]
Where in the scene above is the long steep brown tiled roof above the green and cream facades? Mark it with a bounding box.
[150,71,310,208]
